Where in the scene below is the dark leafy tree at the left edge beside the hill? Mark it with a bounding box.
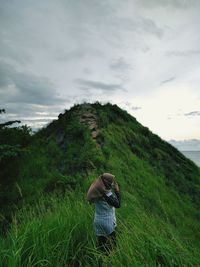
[0,109,31,223]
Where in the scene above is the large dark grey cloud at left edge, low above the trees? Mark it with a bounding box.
[0,61,64,105]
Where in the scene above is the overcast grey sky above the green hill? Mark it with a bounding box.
[0,0,200,140]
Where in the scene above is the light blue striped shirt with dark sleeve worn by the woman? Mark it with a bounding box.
[94,191,120,236]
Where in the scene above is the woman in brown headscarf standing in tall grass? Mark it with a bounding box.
[87,173,121,253]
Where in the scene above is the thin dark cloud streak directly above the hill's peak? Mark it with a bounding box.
[75,79,125,91]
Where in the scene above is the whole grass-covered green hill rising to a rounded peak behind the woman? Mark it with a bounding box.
[0,103,200,267]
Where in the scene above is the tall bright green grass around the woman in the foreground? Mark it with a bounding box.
[0,189,200,267]
